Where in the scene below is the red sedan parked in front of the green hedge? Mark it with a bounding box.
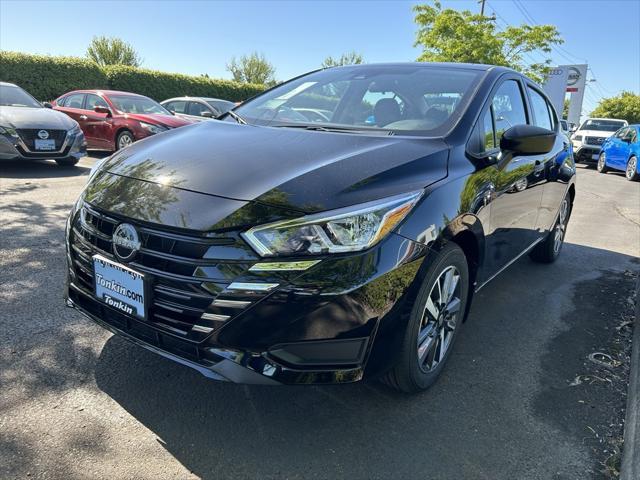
[53,90,193,151]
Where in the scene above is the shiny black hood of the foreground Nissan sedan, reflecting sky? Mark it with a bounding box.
[102,121,448,213]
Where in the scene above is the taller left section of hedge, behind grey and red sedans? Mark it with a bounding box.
[0,51,109,101]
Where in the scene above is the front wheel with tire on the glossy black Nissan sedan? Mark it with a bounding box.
[382,243,469,393]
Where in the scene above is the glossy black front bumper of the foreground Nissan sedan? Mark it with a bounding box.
[65,202,427,384]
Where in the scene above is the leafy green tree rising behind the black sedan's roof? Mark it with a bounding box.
[413,1,564,82]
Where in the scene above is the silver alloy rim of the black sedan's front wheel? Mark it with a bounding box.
[418,265,461,372]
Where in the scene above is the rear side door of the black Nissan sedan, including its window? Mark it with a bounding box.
[527,84,571,234]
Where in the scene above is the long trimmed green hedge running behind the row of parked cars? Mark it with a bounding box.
[0,51,265,102]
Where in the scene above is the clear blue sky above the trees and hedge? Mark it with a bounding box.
[0,0,640,114]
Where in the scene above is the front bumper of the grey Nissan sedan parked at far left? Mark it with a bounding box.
[0,131,87,161]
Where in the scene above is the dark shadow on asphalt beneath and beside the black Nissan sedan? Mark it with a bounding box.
[95,244,639,479]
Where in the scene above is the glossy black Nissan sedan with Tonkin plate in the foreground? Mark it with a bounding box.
[66,63,575,392]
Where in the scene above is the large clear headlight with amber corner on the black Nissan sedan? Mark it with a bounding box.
[242,192,422,257]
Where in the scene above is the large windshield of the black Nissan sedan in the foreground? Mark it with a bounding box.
[234,64,482,136]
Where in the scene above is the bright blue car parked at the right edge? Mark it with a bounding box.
[598,124,640,181]
